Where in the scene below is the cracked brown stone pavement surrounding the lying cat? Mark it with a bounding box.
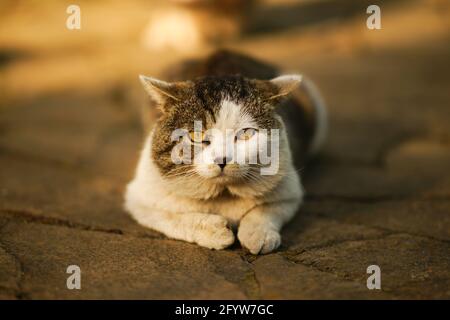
[0,1,450,299]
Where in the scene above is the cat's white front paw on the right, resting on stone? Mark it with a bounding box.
[238,224,281,254]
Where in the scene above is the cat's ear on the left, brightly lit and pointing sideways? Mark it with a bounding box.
[139,75,189,106]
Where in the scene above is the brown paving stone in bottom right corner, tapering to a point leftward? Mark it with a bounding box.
[290,234,450,299]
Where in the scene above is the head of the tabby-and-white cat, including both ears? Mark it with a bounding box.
[140,75,301,198]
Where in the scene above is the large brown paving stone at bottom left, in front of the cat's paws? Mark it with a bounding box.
[1,221,248,299]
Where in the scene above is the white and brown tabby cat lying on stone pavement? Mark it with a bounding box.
[125,50,327,255]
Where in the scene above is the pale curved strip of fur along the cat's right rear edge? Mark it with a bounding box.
[299,75,328,156]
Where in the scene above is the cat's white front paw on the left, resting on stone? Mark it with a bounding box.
[194,215,234,250]
